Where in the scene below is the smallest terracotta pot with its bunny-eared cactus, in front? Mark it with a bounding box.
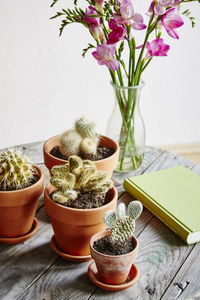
[88,201,143,285]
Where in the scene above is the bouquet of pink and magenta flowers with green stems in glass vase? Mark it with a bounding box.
[51,0,200,171]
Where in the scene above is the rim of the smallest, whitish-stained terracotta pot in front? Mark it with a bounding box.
[90,229,139,259]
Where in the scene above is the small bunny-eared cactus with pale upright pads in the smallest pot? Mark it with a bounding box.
[104,201,143,244]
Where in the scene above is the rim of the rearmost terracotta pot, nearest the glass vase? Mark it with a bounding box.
[43,134,119,163]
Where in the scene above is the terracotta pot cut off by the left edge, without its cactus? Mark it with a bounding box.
[0,166,44,237]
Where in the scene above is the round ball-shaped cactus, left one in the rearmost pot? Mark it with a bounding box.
[60,130,82,157]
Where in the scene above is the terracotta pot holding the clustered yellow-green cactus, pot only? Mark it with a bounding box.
[44,184,117,256]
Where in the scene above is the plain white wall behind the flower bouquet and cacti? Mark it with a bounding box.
[0,0,200,148]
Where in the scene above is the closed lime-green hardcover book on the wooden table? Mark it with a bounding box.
[124,166,200,244]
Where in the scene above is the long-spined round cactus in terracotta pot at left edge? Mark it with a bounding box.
[0,149,44,243]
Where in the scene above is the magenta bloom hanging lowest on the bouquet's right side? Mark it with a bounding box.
[145,38,170,58]
